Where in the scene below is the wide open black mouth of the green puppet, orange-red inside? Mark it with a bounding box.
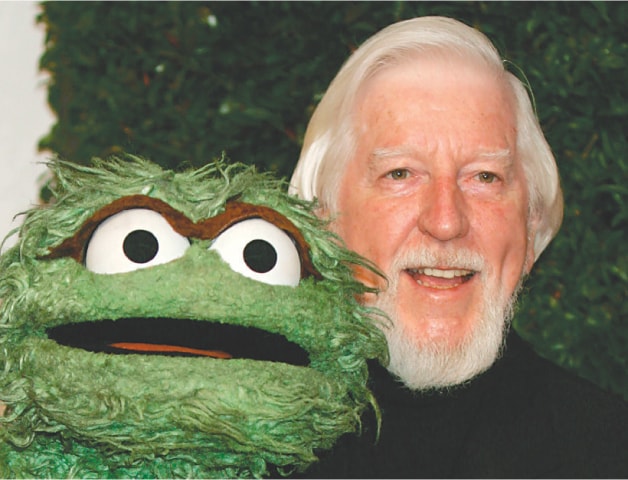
[47,318,309,366]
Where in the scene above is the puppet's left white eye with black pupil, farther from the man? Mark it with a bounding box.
[85,208,190,273]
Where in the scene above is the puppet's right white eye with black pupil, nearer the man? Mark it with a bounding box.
[210,218,301,287]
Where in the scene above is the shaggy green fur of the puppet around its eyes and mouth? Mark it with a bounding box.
[0,156,387,478]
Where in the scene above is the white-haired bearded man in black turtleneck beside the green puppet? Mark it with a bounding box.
[291,17,628,478]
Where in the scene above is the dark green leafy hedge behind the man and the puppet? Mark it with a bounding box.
[39,2,628,399]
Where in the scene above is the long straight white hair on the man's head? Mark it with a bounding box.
[290,17,563,259]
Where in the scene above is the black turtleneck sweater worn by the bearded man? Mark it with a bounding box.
[300,333,628,478]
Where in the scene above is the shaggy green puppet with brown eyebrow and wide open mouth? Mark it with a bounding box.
[0,156,387,478]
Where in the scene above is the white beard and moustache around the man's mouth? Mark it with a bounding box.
[372,250,522,390]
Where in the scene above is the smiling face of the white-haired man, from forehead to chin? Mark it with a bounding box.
[334,58,534,383]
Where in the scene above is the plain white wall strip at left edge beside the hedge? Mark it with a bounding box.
[0,1,54,251]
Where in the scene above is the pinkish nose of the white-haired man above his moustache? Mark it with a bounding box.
[418,179,469,242]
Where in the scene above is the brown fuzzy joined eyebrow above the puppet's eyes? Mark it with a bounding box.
[42,195,321,278]
